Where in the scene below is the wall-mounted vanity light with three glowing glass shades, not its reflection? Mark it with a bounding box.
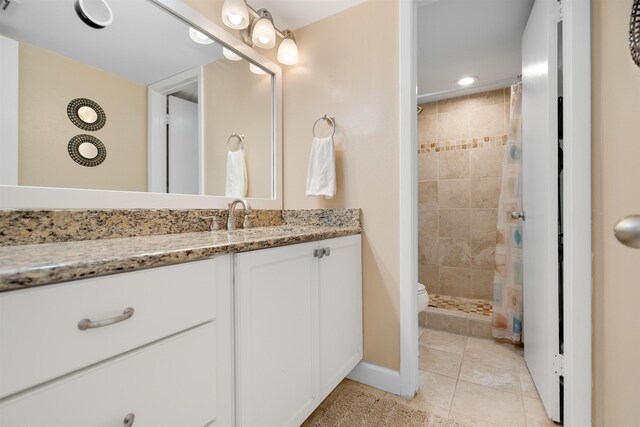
[222,0,298,65]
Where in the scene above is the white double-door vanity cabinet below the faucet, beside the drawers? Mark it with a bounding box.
[235,235,362,427]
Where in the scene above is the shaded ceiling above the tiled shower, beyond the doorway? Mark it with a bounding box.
[418,0,534,100]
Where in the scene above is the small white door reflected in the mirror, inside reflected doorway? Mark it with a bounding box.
[167,95,199,194]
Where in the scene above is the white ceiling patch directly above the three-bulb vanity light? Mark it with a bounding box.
[248,0,365,30]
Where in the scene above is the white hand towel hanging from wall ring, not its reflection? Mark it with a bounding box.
[305,136,336,199]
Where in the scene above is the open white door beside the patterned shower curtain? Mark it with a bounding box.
[522,0,560,421]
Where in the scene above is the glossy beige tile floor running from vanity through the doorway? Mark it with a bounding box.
[303,328,555,427]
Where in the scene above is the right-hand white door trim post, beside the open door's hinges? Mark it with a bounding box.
[562,0,592,427]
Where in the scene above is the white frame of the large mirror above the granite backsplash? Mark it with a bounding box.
[0,0,283,210]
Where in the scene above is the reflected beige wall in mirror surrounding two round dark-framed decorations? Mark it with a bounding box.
[18,43,147,191]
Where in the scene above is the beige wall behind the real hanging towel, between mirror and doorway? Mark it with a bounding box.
[284,0,400,370]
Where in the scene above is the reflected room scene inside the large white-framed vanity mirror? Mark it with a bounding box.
[0,0,276,199]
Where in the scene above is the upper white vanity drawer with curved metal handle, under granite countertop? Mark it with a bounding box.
[0,260,216,398]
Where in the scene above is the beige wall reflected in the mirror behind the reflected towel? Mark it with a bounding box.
[203,59,273,199]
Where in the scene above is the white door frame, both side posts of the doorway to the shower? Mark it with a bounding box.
[399,0,592,426]
